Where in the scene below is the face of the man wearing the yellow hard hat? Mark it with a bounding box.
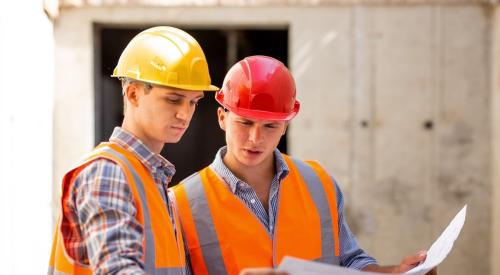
[127,83,203,150]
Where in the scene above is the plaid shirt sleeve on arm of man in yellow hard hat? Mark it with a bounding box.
[72,159,146,274]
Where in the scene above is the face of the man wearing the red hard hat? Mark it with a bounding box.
[217,108,287,170]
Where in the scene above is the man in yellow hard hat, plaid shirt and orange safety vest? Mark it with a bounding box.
[49,27,218,274]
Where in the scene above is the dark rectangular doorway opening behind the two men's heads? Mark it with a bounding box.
[94,25,288,184]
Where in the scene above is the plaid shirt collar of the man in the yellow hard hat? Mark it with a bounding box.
[109,127,175,177]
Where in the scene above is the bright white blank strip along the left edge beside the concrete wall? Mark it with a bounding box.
[0,0,54,275]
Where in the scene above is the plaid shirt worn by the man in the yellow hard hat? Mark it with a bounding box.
[61,127,190,274]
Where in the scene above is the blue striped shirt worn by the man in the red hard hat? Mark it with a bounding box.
[210,147,377,269]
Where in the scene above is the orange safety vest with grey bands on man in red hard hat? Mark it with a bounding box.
[173,155,339,275]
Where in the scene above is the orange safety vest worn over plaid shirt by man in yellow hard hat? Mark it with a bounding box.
[48,143,186,275]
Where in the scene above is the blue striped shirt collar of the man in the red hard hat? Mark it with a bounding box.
[210,146,289,193]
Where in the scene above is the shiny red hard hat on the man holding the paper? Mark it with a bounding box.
[215,55,300,121]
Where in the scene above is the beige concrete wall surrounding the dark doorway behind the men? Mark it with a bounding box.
[54,4,492,275]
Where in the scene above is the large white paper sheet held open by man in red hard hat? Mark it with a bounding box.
[278,205,467,275]
